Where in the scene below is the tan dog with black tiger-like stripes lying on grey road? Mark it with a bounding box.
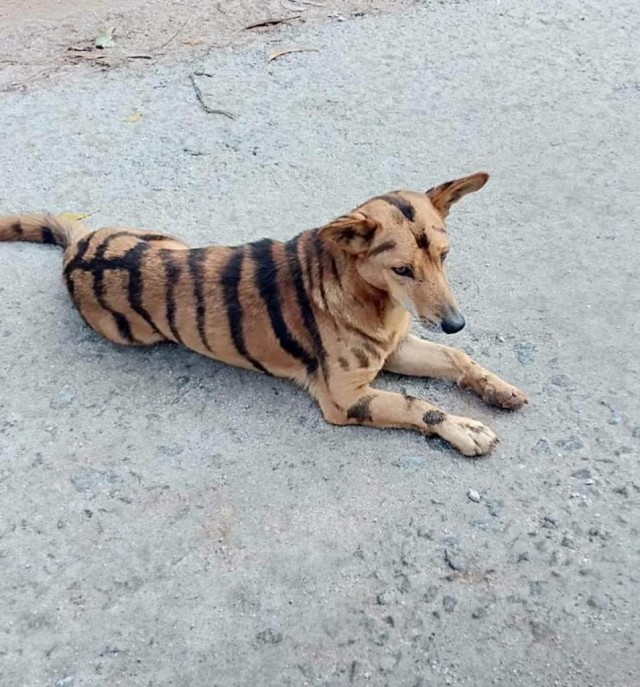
[0,173,528,456]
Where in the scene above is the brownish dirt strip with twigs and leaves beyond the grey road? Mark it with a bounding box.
[0,0,416,90]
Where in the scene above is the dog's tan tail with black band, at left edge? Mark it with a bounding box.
[0,215,90,248]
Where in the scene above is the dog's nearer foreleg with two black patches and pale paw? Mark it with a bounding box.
[318,386,498,456]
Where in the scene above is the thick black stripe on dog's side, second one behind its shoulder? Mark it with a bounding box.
[251,239,318,374]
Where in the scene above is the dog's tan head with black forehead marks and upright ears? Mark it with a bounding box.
[320,172,489,334]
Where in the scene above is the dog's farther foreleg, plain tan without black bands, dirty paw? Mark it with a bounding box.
[384,335,529,410]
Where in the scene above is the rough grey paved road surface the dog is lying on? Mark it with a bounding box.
[0,0,640,687]
